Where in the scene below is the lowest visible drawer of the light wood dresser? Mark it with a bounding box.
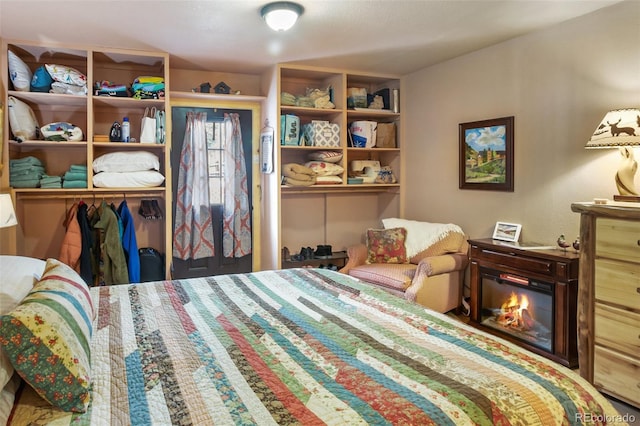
[593,345,640,406]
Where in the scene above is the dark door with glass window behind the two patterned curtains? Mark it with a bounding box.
[171,106,255,279]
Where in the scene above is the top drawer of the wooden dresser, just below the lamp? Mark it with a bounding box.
[596,218,640,263]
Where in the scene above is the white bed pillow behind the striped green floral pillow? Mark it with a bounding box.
[0,255,46,392]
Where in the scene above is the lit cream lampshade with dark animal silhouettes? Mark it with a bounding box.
[585,108,640,148]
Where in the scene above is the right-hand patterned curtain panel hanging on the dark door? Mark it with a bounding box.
[222,113,251,257]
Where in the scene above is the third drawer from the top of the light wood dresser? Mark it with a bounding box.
[595,303,640,357]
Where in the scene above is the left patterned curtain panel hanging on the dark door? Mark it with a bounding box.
[173,112,215,260]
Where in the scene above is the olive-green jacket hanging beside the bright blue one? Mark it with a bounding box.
[93,201,129,285]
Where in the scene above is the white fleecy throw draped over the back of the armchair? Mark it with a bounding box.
[382,218,464,259]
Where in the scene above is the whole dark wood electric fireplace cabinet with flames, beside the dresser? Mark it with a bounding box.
[469,239,579,368]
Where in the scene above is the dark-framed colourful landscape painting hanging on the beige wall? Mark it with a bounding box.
[458,116,515,192]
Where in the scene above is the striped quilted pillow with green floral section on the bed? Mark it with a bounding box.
[0,259,95,412]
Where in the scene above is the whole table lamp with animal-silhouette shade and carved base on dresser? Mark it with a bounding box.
[585,108,640,202]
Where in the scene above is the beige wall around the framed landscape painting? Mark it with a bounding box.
[402,1,640,244]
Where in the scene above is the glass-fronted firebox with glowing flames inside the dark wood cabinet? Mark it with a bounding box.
[479,269,555,353]
